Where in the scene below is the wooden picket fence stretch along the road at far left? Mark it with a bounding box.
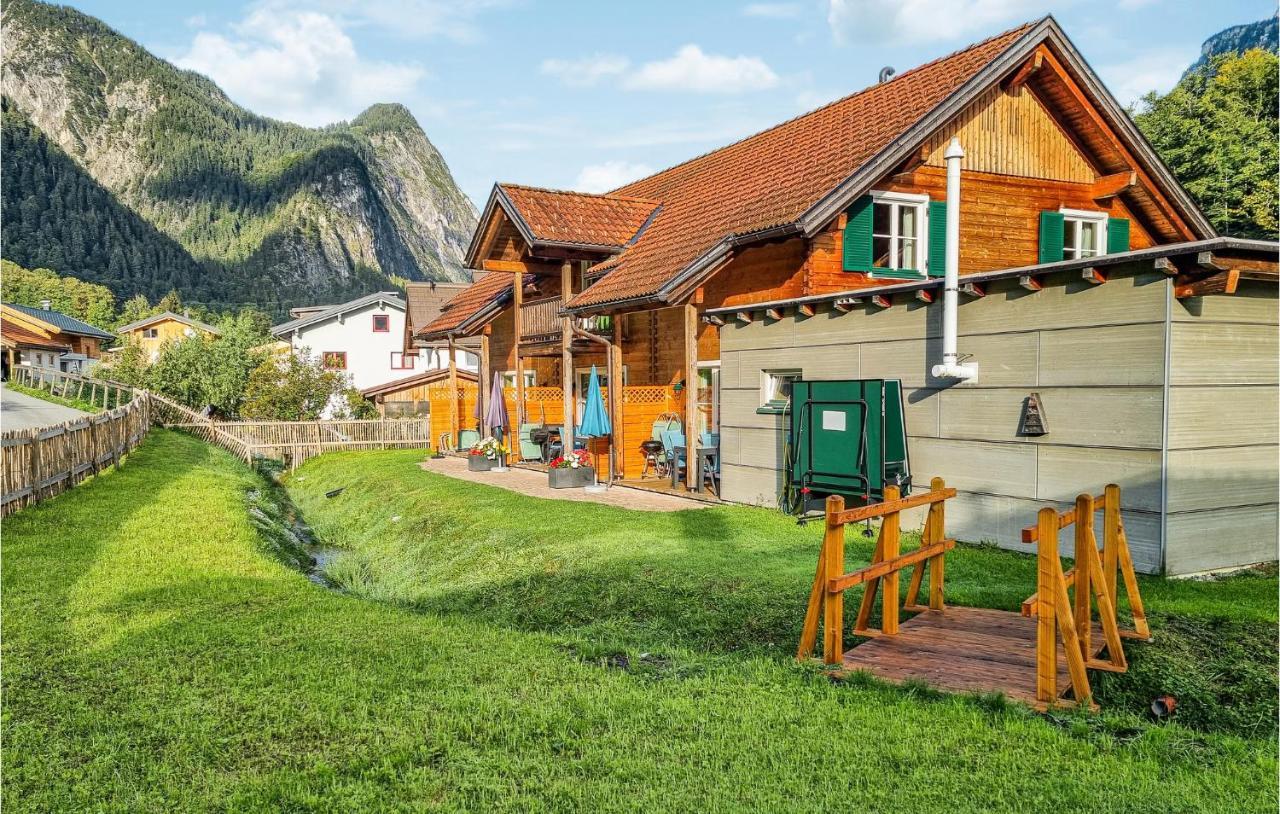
[0,394,151,516]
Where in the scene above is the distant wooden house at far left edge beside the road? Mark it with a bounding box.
[0,299,114,375]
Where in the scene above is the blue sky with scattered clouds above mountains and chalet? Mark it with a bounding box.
[72,0,1275,205]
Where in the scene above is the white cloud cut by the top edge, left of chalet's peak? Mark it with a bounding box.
[827,0,1044,44]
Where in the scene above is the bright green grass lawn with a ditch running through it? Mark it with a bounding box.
[0,431,1276,811]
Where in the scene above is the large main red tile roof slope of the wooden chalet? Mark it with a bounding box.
[570,23,1032,307]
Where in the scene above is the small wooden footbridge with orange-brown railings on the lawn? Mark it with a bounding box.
[796,479,1151,709]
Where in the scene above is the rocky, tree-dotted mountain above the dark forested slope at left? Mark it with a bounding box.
[0,0,476,313]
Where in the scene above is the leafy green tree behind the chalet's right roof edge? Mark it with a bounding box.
[1134,49,1280,239]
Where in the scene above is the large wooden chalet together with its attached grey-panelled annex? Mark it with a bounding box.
[414,18,1277,572]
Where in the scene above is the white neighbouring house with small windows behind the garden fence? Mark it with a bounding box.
[271,292,476,390]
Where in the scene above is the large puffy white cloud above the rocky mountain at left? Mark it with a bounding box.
[174,8,425,125]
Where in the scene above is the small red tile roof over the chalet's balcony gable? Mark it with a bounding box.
[498,184,658,248]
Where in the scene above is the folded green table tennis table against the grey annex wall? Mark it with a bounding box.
[788,379,910,506]
